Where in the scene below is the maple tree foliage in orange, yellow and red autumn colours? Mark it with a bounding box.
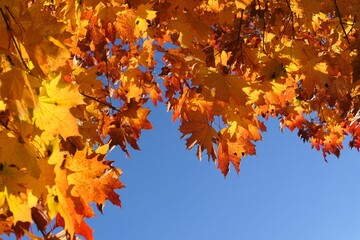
[0,0,360,239]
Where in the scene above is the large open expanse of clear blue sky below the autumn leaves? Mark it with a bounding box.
[89,105,360,240]
